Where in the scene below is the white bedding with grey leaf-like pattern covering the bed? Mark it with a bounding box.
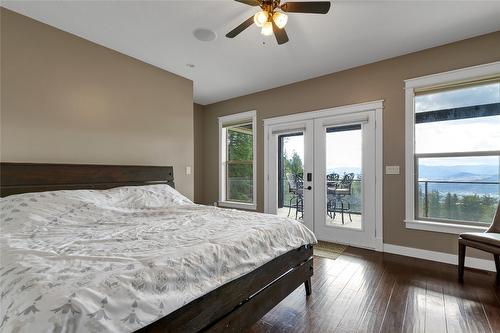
[0,185,316,332]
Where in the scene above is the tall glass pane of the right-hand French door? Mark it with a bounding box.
[323,124,363,230]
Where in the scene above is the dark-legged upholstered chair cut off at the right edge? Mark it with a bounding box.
[458,203,500,283]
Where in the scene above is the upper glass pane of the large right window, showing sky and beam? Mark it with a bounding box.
[415,82,500,154]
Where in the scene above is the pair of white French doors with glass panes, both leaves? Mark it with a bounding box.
[265,104,382,248]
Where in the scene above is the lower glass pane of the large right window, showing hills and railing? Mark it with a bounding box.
[416,156,500,224]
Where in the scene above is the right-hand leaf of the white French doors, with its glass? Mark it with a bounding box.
[313,111,375,248]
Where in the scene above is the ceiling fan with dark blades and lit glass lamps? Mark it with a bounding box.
[226,0,331,45]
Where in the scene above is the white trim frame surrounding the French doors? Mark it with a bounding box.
[263,100,384,251]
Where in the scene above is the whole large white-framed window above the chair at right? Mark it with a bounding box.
[406,64,500,233]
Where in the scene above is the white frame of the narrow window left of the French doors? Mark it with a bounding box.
[218,111,257,210]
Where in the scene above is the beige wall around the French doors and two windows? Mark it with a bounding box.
[196,32,500,253]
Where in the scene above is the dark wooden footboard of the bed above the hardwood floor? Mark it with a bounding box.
[137,245,313,332]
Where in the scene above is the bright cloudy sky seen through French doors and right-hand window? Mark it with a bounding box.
[285,83,500,169]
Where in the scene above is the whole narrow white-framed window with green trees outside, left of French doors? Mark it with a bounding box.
[219,111,256,209]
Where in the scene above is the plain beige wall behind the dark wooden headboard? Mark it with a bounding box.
[0,9,194,197]
